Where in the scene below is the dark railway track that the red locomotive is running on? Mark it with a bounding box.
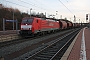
[0,28,72,48]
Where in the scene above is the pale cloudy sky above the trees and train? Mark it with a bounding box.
[0,0,90,23]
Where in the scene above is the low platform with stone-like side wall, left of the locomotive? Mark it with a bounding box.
[0,30,21,43]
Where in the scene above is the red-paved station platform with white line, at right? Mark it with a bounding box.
[60,27,90,60]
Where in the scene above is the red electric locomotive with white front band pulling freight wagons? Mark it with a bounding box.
[20,17,60,35]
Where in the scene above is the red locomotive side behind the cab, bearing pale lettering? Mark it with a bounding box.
[41,20,59,31]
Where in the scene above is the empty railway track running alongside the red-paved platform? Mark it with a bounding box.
[24,30,79,60]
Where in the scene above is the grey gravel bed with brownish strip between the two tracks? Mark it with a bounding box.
[0,29,80,60]
